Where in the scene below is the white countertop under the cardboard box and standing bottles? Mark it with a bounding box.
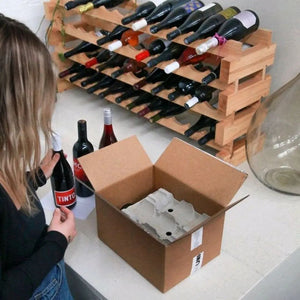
[39,88,300,300]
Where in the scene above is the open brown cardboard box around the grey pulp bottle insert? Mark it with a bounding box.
[79,136,247,292]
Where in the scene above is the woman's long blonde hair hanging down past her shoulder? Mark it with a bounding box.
[0,14,56,213]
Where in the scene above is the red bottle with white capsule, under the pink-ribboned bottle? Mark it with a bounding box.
[164,47,209,74]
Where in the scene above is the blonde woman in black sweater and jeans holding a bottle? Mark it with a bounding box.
[0,14,76,300]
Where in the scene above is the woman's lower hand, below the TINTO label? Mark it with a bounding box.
[48,206,76,243]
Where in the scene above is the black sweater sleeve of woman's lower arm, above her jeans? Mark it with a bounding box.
[0,231,68,300]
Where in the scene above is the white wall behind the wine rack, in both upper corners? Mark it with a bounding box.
[0,0,300,92]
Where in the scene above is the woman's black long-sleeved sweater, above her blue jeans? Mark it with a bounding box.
[0,172,68,300]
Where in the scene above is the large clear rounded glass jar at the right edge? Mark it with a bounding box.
[246,74,300,195]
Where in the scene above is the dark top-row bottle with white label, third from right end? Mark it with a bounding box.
[167,2,223,40]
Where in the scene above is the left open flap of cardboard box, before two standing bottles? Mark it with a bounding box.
[78,136,152,192]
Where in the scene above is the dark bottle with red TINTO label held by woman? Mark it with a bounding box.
[51,134,76,209]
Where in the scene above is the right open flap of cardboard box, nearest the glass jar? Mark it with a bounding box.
[155,138,247,207]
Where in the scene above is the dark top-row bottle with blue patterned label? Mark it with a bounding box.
[150,0,204,34]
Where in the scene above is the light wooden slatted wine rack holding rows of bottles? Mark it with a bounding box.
[44,0,276,165]
